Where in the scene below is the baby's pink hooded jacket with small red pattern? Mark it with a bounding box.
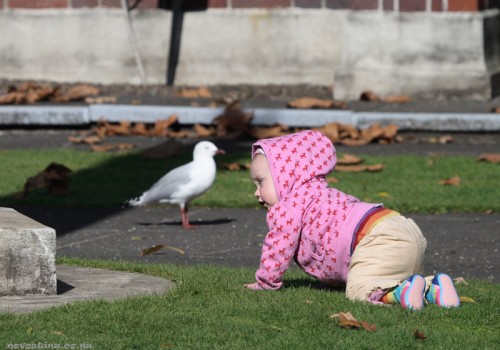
[252,130,380,289]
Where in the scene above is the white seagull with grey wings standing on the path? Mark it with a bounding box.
[127,141,225,228]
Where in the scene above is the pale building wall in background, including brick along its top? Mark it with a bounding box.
[0,0,500,100]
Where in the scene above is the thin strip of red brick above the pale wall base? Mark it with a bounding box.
[0,0,500,12]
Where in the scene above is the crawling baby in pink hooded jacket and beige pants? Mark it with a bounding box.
[245,130,460,310]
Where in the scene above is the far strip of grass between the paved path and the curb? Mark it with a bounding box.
[0,149,500,213]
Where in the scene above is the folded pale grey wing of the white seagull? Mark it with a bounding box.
[144,162,193,203]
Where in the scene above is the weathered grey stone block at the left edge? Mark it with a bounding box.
[0,208,57,296]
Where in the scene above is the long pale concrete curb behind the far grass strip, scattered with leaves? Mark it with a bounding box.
[0,104,500,132]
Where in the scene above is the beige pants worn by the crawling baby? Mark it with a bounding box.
[346,216,427,301]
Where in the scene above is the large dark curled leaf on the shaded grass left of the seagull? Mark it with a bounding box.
[21,163,73,198]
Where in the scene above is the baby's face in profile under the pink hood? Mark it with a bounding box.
[250,154,278,209]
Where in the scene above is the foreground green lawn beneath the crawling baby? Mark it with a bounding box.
[0,258,500,349]
